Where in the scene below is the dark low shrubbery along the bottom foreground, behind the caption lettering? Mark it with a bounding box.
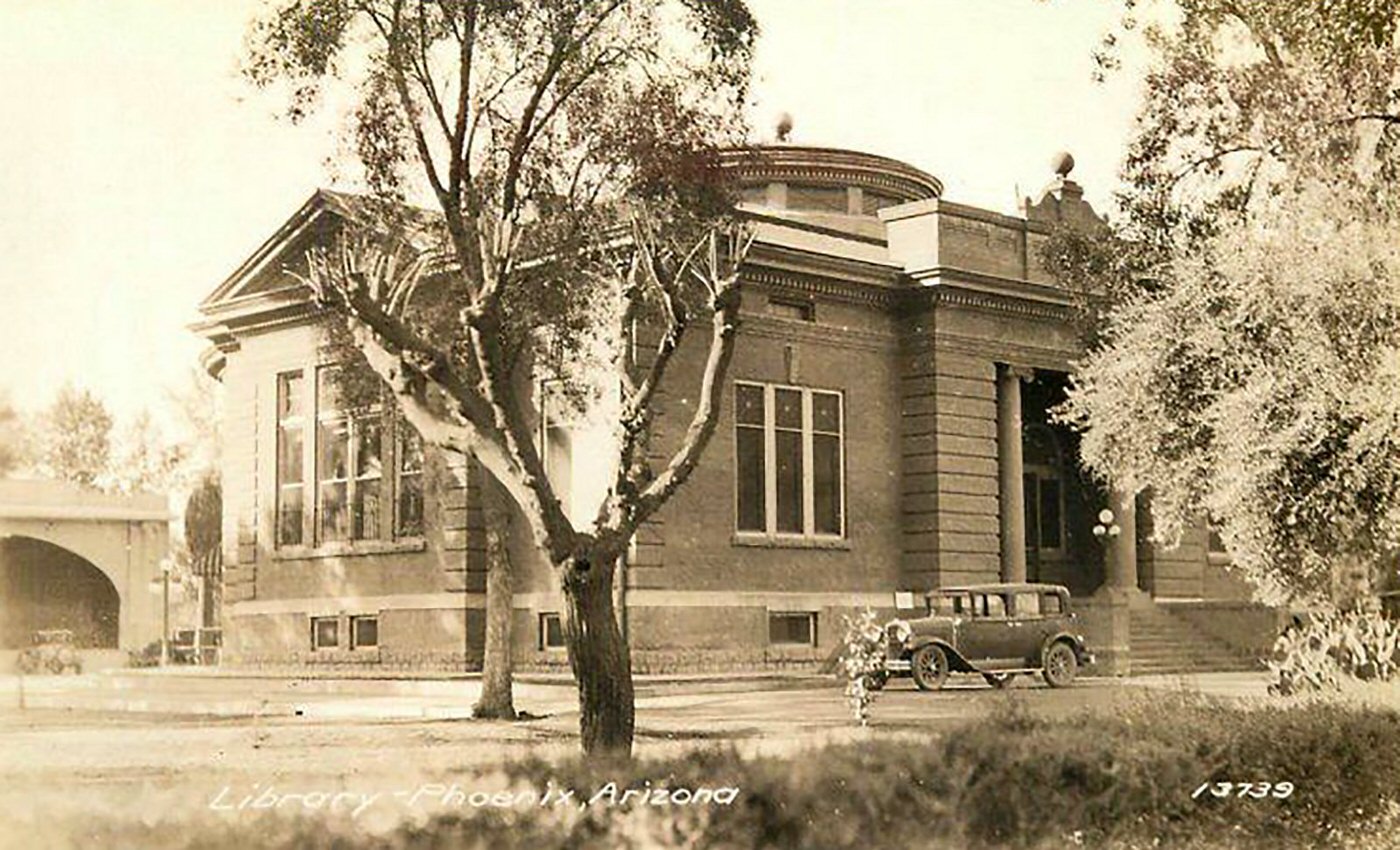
[54,693,1400,850]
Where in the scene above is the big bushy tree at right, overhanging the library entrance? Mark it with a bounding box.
[1051,0,1400,595]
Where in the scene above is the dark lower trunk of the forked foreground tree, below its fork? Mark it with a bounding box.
[561,552,636,759]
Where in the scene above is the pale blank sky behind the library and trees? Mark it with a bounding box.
[0,0,1142,431]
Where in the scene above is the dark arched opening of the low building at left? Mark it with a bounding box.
[0,536,122,650]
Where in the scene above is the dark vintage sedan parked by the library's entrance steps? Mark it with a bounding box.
[874,584,1093,690]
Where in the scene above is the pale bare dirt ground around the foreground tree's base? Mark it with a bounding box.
[0,676,1263,847]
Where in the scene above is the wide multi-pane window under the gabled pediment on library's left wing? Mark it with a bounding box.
[277,365,423,546]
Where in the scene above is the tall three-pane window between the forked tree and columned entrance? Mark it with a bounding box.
[735,382,844,536]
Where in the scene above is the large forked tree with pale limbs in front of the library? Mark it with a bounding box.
[246,0,756,753]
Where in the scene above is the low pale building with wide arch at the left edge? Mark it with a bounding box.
[0,480,169,650]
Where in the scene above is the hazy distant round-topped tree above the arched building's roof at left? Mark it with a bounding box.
[36,384,112,487]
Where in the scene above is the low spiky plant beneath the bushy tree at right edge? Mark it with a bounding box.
[1267,611,1400,695]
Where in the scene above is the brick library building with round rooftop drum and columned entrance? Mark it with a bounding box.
[195,146,1275,674]
